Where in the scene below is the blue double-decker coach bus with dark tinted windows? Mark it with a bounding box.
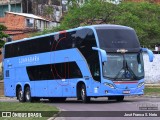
[3,24,153,103]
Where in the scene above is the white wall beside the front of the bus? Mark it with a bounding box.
[143,54,160,84]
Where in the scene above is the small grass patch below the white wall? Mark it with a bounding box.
[144,87,160,96]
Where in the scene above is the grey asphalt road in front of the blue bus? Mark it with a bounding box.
[48,97,160,120]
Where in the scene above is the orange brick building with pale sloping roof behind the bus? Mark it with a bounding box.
[4,12,53,40]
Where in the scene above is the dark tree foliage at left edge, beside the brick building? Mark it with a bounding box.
[0,24,8,48]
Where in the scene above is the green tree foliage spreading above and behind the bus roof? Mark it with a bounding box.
[58,0,160,48]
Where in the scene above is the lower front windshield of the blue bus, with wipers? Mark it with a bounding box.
[103,53,144,80]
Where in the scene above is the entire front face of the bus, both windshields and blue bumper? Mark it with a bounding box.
[96,26,144,96]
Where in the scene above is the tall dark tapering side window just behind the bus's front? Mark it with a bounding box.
[76,29,100,81]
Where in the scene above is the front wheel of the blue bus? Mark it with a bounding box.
[81,84,90,103]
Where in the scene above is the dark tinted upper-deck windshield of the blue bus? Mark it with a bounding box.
[96,28,140,52]
